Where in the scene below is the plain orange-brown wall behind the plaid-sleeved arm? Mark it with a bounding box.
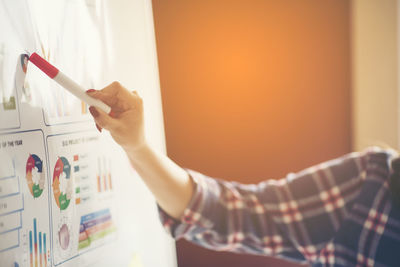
[153,0,351,267]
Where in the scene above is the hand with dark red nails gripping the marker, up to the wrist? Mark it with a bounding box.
[86,82,146,152]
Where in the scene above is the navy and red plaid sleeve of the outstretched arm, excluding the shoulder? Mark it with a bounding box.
[159,151,374,262]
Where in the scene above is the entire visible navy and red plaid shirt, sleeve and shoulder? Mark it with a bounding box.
[159,148,400,266]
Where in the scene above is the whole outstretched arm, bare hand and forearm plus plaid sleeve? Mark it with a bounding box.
[89,83,387,262]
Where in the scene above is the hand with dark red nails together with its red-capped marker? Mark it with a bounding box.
[29,53,145,151]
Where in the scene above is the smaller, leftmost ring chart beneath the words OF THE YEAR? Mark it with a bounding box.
[26,154,45,198]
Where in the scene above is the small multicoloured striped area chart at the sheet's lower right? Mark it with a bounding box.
[78,209,116,250]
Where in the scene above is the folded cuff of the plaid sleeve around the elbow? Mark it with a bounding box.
[157,169,214,239]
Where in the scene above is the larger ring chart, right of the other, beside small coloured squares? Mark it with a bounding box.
[52,157,73,210]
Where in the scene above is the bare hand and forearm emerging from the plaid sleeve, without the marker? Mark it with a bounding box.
[87,82,193,219]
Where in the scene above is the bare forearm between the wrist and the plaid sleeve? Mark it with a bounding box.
[126,145,193,219]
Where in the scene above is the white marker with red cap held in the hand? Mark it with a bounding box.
[29,53,111,114]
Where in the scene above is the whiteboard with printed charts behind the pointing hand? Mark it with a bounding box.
[0,0,176,267]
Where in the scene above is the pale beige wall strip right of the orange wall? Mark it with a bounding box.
[351,0,400,150]
